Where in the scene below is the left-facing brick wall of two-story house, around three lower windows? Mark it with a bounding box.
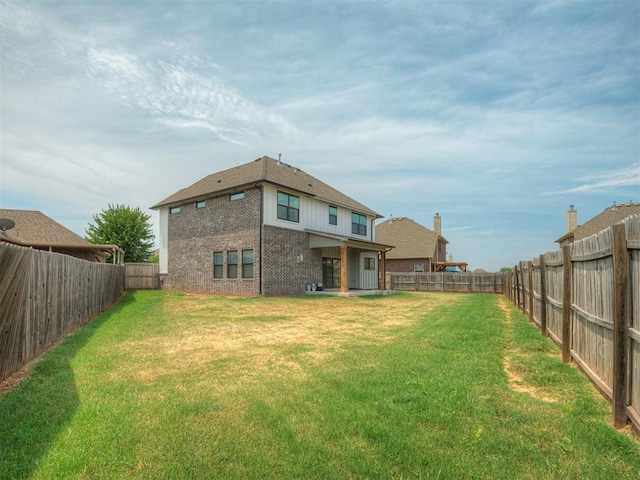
[168,188,261,296]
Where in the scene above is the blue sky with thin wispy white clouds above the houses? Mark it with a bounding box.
[0,0,640,271]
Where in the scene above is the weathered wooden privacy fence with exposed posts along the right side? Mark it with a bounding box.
[504,215,640,431]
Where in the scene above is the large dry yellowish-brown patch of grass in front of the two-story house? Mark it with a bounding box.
[114,295,453,383]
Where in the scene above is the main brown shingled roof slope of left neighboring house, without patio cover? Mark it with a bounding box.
[0,208,91,246]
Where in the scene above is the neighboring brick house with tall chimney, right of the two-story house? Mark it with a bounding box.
[376,213,448,273]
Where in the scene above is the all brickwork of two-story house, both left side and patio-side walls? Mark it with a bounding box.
[162,189,322,296]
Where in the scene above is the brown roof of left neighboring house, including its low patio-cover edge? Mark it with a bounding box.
[0,208,122,253]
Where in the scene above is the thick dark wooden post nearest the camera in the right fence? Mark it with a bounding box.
[612,223,631,428]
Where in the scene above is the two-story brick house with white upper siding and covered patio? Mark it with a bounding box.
[151,157,391,295]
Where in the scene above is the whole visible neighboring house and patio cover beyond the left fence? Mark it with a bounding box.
[0,208,124,263]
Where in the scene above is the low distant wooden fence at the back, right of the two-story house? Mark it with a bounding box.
[386,272,503,293]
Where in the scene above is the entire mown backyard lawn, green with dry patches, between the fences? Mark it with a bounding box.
[0,291,640,480]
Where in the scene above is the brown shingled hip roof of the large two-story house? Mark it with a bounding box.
[151,156,382,218]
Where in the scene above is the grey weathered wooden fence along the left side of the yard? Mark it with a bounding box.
[0,243,125,381]
